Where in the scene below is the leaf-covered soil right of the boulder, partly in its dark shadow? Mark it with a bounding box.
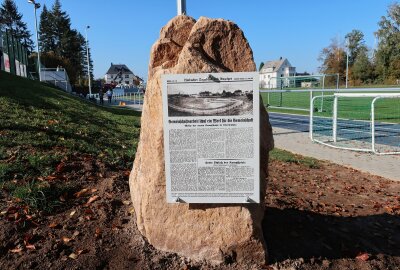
[264,158,400,270]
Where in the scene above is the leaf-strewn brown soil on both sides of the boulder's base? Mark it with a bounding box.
[0,153,400,270]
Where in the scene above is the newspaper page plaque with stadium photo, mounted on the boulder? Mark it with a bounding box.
[162,72,260,203]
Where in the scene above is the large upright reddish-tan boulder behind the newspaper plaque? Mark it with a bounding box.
[129,15,273,263]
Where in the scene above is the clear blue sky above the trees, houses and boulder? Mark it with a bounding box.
[16,0,394,78]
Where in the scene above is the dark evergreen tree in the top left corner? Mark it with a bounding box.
[0,0,34,51]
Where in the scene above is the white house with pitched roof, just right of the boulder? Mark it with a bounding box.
[260,57,296,89]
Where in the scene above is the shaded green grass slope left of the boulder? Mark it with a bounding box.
[0,72,140,211]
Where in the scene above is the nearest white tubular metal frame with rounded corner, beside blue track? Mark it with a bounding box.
[310,93,400,155]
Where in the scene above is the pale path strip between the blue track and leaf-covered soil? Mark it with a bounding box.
[273,127,400,181]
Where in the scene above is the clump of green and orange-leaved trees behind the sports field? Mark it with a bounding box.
[318,3,400,85]
